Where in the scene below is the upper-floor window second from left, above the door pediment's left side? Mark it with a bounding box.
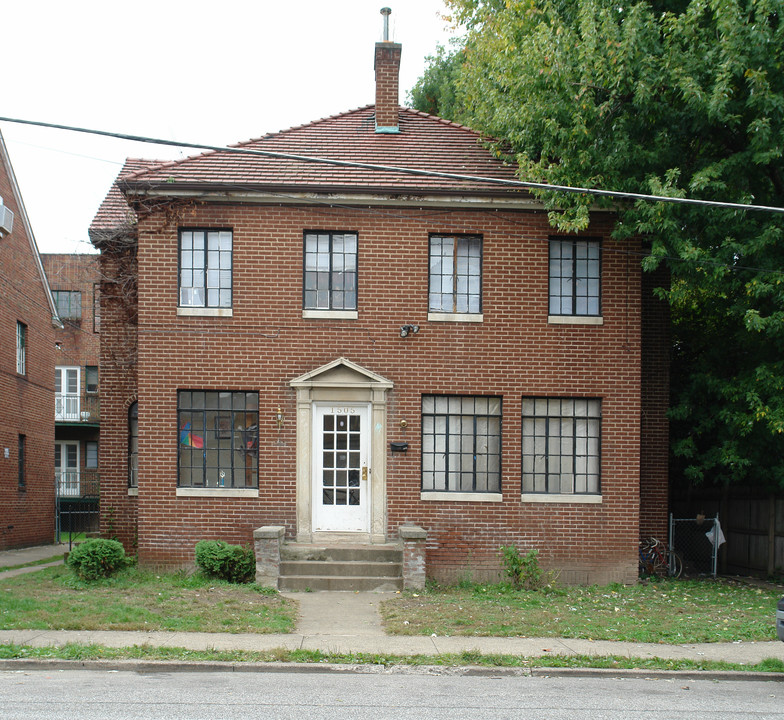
[303,231,357,310]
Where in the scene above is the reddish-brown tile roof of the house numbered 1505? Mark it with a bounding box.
[119,105,527,198]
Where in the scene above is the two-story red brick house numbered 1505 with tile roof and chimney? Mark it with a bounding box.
[91,42,667,582]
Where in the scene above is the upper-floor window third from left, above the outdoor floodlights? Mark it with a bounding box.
[428,235,482,314]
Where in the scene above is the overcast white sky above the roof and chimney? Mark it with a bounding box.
[0,0,452,252]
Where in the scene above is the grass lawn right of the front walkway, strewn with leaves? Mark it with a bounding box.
[381,580,782,644]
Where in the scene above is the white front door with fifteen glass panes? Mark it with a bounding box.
[311,403,371,532]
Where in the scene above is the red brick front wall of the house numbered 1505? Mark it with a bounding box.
[102,200,641,582]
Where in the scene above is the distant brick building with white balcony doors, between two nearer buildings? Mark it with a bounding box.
[41,253,100,531]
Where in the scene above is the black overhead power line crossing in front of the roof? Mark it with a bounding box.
[0,117,784,214]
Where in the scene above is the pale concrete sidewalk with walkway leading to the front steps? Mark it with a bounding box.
[0,546,784,665]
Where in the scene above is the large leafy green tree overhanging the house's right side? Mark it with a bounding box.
[423,0,784,487]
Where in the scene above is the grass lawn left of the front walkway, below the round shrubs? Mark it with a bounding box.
[0,565,297,633]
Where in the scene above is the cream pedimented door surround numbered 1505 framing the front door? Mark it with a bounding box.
[289,357,393,543]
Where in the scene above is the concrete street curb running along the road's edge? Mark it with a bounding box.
[0,658,784,682]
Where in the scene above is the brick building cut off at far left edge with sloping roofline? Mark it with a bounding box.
[0,129,60,549]
